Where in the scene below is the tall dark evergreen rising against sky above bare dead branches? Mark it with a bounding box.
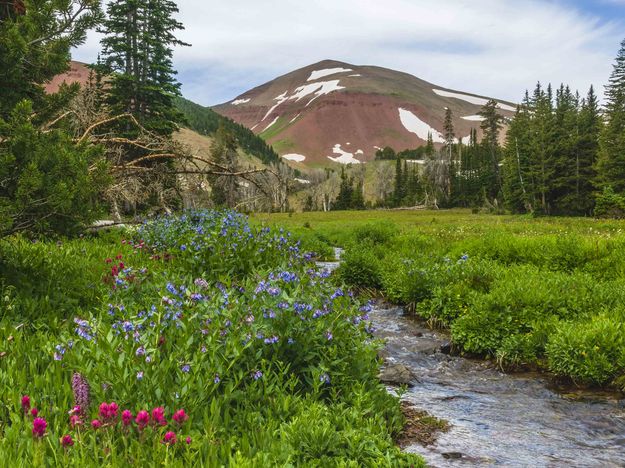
[101,0,188,136]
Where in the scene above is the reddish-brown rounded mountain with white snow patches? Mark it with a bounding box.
[213,60,516,166]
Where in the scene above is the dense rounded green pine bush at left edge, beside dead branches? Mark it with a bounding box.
[0,101,108,236]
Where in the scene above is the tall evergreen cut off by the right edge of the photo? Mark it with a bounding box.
[597,36,625,194]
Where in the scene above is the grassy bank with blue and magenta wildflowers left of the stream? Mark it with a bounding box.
[0,212,422,466]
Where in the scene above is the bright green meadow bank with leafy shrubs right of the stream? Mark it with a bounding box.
[257,210,625,389]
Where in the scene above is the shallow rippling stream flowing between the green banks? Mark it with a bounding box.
[319,250,625,467]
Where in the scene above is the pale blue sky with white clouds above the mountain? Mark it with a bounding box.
[73,0,625,105]
